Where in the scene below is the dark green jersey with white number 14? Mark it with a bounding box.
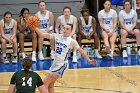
[10,70,43,93]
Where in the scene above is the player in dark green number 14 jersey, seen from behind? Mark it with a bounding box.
[7,57,47,93]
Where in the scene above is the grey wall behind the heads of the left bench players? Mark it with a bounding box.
[0,0,84,19]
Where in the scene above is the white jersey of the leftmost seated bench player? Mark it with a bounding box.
[1,19,15,35]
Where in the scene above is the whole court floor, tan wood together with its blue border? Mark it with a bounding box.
[0,55,140,93]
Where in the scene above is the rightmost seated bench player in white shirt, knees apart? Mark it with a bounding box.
[119,0,140,58]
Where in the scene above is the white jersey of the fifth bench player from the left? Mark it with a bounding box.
[80,16,93,35]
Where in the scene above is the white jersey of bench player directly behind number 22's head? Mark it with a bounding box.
[59,15,74,34]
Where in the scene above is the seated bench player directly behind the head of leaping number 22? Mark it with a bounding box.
[56,6,77,62]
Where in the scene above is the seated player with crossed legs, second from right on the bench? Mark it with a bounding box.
[98,0,117,59]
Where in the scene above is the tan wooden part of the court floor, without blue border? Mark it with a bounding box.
[0,66,140,93]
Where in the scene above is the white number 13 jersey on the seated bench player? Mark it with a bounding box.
[37,10,50,31]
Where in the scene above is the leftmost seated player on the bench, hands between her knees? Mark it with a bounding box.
[0,11,17,63]
